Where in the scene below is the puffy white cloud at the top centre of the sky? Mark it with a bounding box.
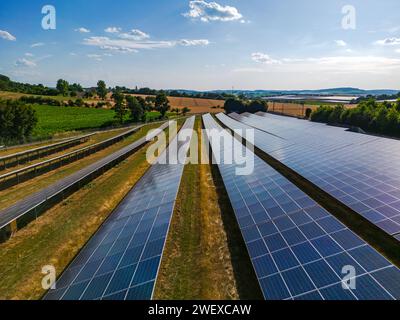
[183,0,245,23]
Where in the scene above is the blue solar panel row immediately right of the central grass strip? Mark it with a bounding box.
[203,115,400,300]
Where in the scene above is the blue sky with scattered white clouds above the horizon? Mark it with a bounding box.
[0,0,400,90]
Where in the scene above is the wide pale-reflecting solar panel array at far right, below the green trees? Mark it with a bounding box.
[218,114,400,240]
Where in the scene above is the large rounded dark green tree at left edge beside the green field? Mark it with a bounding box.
[0,100,38,143]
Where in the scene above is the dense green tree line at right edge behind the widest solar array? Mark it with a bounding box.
[311,99,400,137]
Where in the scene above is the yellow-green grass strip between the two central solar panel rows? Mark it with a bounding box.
[155,119,259,300]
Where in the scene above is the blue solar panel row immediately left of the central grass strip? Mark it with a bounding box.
[45,117,194,300]
